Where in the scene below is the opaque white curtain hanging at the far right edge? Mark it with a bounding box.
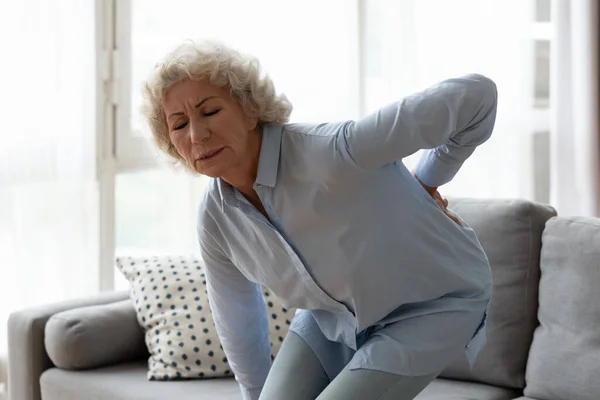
[550,0,600,216]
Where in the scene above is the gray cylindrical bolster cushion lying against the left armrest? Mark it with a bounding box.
[45,300,148,369]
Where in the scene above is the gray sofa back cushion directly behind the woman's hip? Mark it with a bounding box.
[441,199,556,389]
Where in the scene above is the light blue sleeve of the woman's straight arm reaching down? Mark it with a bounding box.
[200,231,271,400]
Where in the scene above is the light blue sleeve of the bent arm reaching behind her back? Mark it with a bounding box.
[337,74,497,186]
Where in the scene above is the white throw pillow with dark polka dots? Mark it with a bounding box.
[116,256,294,380]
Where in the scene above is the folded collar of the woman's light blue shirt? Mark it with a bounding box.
[218,125,283,211]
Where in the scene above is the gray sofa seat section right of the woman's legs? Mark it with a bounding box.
[415,379,520,400]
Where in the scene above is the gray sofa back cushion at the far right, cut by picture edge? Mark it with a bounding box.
[525,217,600,400]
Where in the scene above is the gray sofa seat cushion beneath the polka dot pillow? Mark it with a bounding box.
[40,361,242,400]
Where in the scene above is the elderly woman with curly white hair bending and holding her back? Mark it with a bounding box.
[144,42,497,400]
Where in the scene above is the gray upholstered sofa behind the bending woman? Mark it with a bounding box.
[8,199,600,400]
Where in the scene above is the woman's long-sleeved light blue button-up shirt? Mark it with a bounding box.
[198,74,497,399]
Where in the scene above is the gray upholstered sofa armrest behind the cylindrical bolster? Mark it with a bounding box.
[8,291,129,400]
